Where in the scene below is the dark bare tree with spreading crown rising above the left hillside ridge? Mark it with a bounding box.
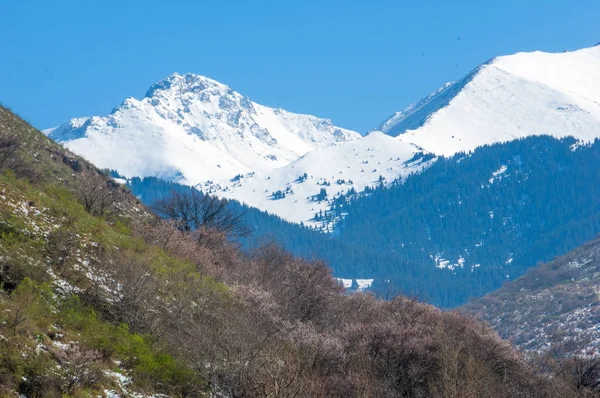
[154,188,251,238]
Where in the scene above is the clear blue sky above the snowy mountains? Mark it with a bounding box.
[0,0,600,132]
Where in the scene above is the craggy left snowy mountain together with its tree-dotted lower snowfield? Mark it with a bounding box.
[45,74,427,224]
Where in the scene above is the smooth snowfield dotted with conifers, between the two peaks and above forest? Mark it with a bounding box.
[198,133,433,230]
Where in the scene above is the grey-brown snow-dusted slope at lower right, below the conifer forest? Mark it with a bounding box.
[462,239,600,355]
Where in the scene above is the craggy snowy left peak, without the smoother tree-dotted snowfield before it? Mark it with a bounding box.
[46,74,360,185]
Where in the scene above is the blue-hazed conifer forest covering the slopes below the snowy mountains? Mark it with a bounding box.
[124,136,600,308]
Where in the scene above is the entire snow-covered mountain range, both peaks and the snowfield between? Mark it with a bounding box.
[45,46,600,230]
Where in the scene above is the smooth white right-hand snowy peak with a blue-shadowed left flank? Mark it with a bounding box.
[377,46,600,155]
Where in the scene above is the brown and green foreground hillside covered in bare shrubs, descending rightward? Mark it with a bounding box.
[0,104,591,398]
